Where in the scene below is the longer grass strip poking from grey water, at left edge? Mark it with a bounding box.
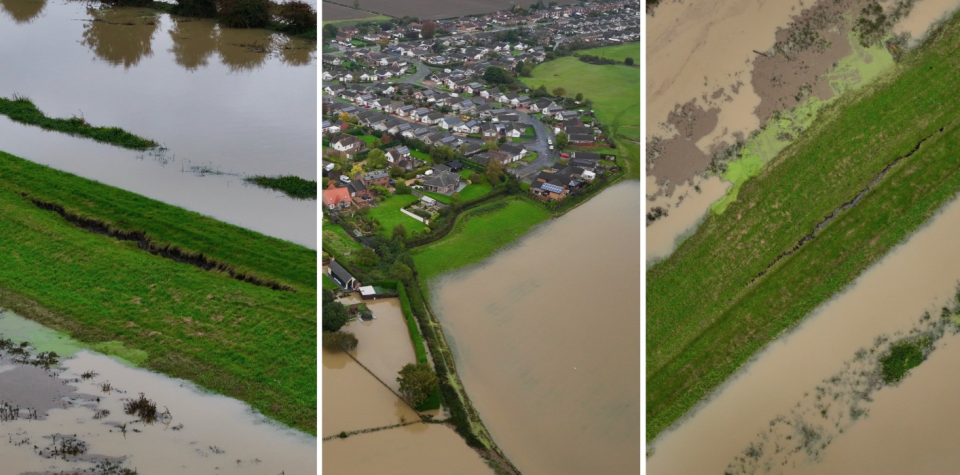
[0,96,157,150]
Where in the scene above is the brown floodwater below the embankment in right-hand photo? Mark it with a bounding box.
[647,193,960,475]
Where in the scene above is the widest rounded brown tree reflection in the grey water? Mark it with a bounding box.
[83,7,158,69]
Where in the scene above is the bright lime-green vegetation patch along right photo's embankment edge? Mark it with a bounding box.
[710,34,894,214]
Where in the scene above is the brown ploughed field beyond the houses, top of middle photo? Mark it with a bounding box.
[323,0,575,20]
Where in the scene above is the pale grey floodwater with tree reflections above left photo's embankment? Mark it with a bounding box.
[0,0,317,248]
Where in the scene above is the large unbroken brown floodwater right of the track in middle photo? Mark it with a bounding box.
[431,181,641,475]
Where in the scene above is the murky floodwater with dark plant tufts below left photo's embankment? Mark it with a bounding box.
[0,312,317,475]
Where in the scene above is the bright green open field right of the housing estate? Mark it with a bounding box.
[521,47,641,179]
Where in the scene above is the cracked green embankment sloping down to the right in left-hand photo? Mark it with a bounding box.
[0,152,317,433]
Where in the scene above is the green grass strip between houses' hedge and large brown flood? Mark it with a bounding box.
[413,200,550,284]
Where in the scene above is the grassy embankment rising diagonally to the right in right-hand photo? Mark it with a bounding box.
[646,17,960,440]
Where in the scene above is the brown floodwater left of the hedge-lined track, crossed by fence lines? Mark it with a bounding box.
[321,297,491,475]
